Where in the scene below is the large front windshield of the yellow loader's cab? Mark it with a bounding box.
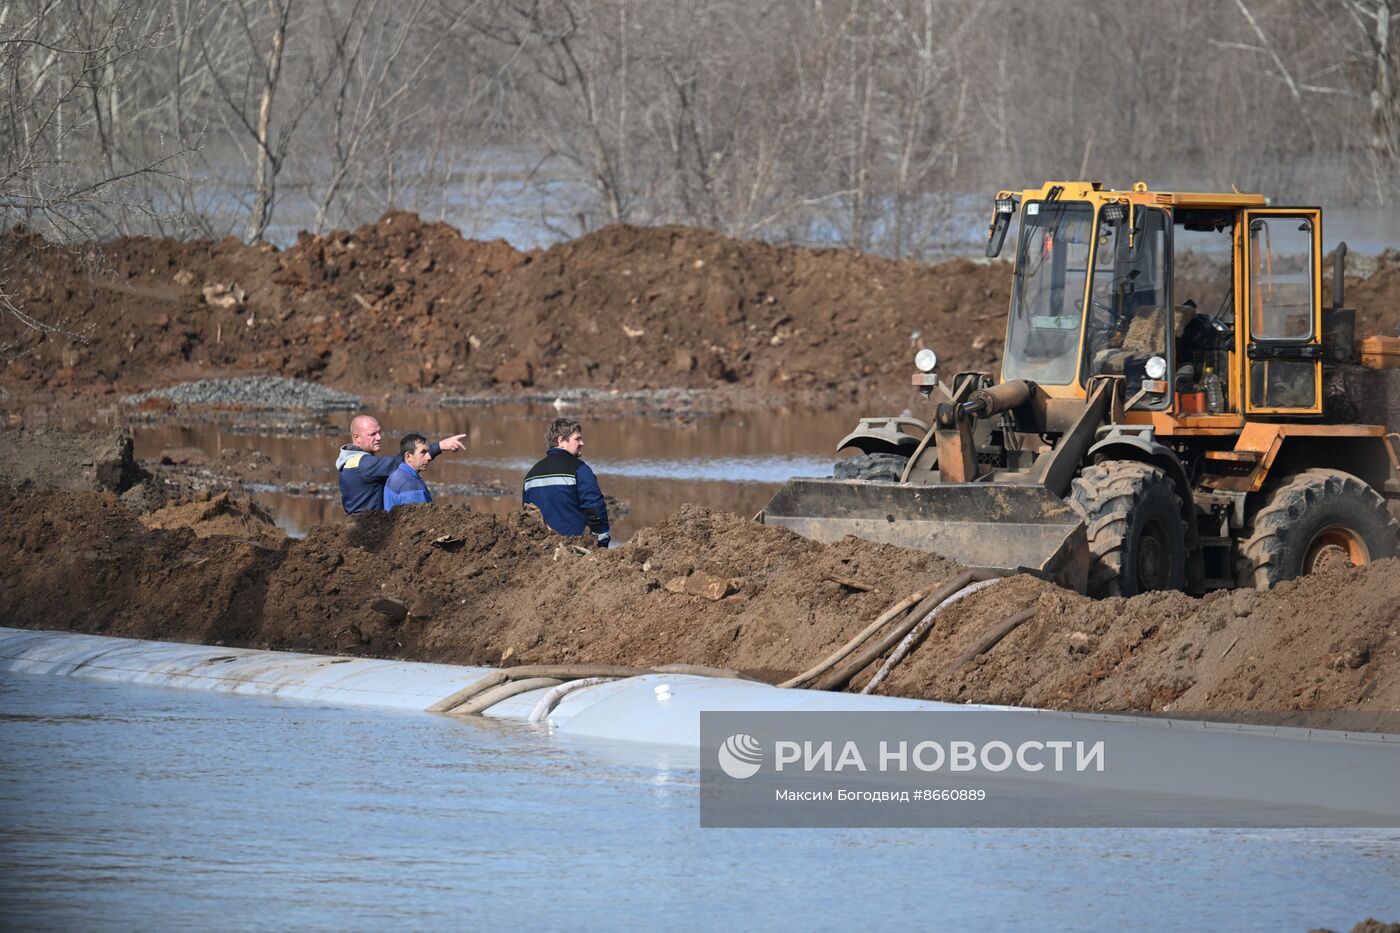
[1002,200,1093,385]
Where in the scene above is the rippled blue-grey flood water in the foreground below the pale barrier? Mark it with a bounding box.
[0,672,1400,933]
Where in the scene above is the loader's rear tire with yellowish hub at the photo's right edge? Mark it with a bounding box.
[1235,469,1400,590]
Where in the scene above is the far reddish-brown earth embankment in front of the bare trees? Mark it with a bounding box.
[10,212,1400,406]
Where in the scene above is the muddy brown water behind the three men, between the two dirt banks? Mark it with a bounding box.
[132,403,871,541]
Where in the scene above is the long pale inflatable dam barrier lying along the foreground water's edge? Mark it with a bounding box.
[0,628,1400,827]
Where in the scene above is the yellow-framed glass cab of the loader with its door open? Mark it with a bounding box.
[988,182,1322,417]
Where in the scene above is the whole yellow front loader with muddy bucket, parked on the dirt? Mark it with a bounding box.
[760,182,1400,595]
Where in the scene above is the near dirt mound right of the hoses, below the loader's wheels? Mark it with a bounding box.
[879,560,1400,710]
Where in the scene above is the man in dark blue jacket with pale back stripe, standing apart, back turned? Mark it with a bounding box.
[524,417,612,548]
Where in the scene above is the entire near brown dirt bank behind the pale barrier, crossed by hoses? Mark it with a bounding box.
[0,488,1400,712]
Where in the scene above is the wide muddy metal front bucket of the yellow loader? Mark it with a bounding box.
[759,479,1089,593]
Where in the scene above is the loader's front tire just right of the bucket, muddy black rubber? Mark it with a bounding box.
[1070,459,1186,597]
